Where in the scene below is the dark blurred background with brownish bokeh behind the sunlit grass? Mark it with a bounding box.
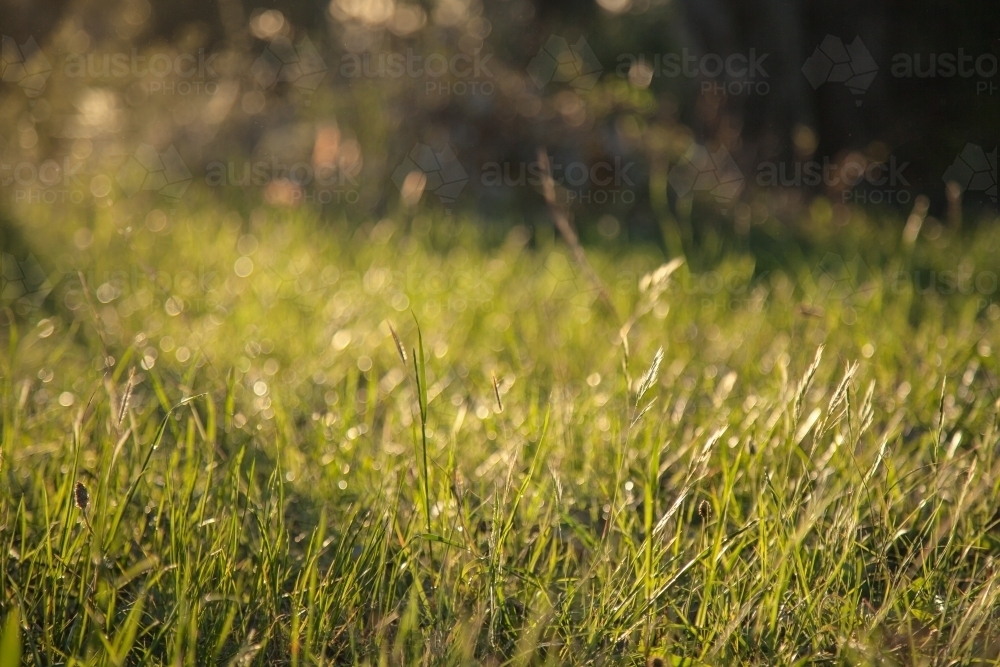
[0,0,1000,254]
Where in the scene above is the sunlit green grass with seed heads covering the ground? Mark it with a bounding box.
[0,205,1000,665]
